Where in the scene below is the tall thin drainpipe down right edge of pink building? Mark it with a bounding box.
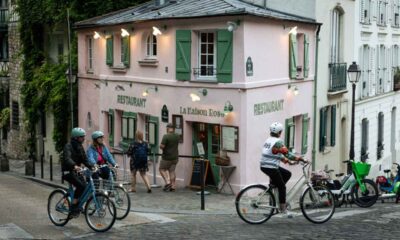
[311,25,321,170]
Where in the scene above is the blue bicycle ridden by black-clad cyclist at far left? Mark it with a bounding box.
[47,168,116,232]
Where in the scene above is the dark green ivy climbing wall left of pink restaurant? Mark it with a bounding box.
[16,0,146,152]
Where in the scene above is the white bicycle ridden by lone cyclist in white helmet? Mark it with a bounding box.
[235,162,335,224]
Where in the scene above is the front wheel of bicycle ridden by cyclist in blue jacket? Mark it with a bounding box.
[110,186,131,220]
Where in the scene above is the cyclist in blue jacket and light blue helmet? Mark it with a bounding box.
[86,131,118,186]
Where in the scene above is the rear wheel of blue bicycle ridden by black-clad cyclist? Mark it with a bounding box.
[47,189,71,226]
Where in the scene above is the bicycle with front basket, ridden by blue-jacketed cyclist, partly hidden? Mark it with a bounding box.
[95,164,131,220]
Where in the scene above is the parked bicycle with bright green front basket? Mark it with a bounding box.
[314,160,379,208]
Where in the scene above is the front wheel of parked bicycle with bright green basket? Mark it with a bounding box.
[352,179,379,208]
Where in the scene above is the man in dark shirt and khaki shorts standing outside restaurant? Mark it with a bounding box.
[159,123,180,192]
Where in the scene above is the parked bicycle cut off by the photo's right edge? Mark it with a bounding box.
[376,163,400,203]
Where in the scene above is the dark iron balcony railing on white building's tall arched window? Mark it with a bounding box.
[328,63,347,93]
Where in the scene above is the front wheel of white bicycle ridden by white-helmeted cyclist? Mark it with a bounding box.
[300,186,335,224]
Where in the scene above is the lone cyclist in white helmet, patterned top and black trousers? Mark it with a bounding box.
[260,122,304,218]
